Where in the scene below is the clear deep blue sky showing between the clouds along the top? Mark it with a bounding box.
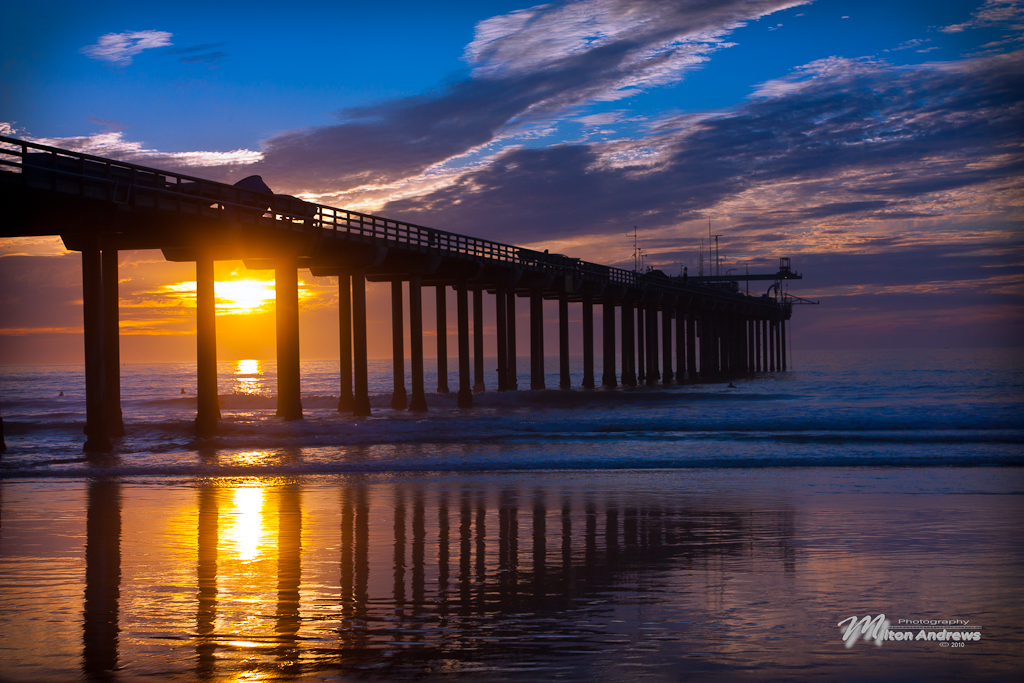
[2,0,1006,152]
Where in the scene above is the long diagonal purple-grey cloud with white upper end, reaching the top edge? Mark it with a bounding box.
[249,0,802,193]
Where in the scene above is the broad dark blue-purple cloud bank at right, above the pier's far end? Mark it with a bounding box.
[381,52,1024,253]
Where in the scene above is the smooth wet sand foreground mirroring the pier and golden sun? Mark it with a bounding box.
[0,473,1024,683]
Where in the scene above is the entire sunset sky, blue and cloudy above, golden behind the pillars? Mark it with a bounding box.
[0,0,1024,364]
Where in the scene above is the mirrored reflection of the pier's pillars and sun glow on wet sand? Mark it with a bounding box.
[83,481,795,678]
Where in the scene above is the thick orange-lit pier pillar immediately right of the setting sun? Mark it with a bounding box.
[274,258,302,420]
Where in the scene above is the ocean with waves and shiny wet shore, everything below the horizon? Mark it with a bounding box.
[0,349,1024,681]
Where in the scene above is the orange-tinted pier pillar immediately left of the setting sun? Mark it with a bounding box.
[196,256,220,436]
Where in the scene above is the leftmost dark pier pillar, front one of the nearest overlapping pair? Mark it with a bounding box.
[82,244,112,453]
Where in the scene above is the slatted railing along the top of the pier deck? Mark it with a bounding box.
[0,136,774,301]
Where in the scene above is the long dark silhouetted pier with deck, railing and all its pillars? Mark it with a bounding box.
[0,136,801,452]
